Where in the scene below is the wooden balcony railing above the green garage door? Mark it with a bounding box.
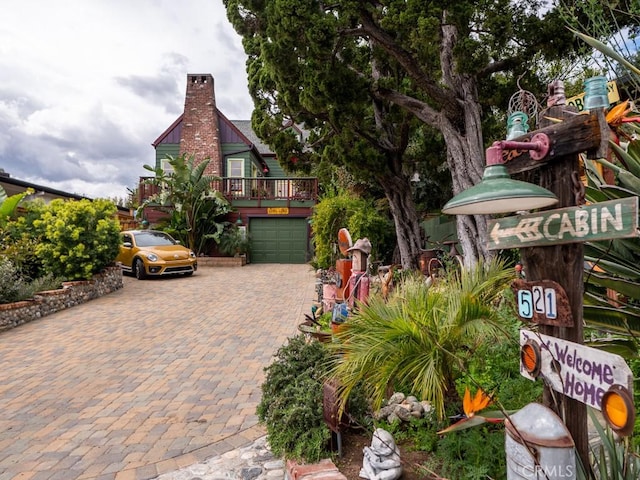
[138,177,318,205]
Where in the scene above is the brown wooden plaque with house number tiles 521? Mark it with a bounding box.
[511,280,573,327]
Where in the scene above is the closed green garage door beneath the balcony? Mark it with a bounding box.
[249,217,307,263]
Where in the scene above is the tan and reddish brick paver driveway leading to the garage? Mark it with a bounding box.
[0,265,315,480]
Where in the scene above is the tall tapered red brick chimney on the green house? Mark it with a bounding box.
[180,74,223,177]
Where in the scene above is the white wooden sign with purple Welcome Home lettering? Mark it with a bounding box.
[520,329,633,410]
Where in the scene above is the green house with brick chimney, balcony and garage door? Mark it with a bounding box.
[139,74,318,263]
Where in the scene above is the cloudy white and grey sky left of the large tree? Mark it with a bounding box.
[0,0,253,198]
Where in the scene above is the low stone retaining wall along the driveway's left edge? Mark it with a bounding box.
[0,267,124,331]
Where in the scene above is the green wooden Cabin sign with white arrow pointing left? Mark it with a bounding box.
[487,197,638,250]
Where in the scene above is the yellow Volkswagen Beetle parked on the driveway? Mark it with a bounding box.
[116,230,198,280]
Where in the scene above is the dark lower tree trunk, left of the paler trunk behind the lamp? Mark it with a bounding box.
[380,175,422,270]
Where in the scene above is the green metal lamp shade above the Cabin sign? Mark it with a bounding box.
[442,165,558,215]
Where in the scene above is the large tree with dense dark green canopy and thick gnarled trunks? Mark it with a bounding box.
[224,0,596,266]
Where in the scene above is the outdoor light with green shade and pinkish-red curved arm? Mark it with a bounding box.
[442,133,558,215]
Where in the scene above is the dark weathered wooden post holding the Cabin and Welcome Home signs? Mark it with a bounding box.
[520,107,589,468]
